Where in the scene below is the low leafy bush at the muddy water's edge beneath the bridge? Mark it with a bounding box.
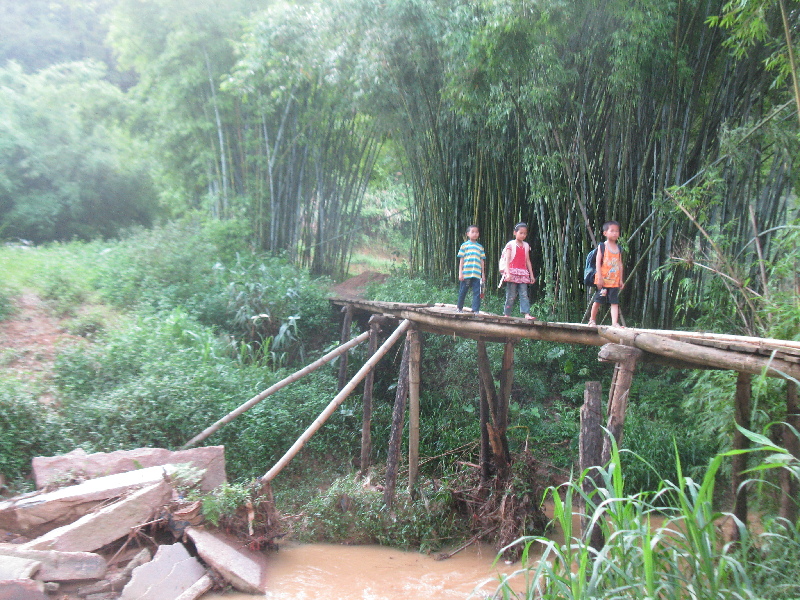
[295,475,460,551]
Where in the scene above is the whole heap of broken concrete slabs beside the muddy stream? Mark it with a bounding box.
[0,446,277,600]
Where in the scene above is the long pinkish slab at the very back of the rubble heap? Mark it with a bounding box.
[33,446,227,491]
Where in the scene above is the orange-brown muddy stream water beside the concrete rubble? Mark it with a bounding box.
[203,543,519,600]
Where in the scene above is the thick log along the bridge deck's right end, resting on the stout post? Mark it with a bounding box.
[598,327,800,378]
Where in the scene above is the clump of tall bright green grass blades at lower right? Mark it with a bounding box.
[492,432,798,600]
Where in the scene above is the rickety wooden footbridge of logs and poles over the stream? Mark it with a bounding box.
[184,297,800,535]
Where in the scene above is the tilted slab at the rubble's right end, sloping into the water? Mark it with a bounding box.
[186,527,266,594]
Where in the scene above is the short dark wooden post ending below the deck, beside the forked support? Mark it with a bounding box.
[579,381,605,550]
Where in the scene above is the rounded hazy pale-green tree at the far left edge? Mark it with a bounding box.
[0,62,157,242]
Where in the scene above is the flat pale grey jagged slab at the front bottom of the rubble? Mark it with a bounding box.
[120,544,206,600]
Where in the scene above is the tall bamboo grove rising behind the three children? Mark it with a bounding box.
[14,0,800,331]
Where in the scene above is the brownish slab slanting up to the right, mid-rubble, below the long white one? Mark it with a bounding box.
[21,478,172,552]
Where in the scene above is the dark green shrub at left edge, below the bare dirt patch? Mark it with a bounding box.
[0,378,70,487]
